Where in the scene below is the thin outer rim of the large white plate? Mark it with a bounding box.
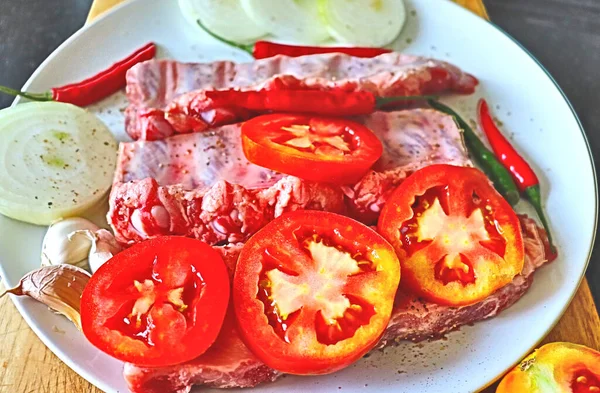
[0,0,599,392]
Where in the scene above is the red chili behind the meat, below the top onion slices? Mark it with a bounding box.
[198,20,392,59]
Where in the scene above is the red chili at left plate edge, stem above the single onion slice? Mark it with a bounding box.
[0,43,156,106]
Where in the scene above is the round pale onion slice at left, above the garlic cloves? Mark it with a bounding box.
[0,102,117,225]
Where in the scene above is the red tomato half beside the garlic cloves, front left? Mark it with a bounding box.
[81,236,230,366]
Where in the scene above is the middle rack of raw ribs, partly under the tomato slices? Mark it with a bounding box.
[108,109,470,244]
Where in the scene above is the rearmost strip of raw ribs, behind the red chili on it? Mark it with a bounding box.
[126,53,478,140]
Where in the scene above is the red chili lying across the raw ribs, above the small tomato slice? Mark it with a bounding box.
[202,89,433,116]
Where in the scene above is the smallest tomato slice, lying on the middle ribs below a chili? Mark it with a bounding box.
[242,114,383,184]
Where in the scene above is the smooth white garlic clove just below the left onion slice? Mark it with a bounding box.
[42,217,100,269]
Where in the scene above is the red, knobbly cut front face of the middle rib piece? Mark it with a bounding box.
[108,176,345,244]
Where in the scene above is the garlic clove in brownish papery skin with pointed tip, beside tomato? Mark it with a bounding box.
[0,265,91,330]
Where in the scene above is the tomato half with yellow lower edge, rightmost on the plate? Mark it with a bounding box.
[378,165,524,306]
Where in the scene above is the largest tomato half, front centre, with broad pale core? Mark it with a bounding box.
[233,211,400,375]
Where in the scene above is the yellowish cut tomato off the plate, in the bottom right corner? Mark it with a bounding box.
[496,343,600,393]
